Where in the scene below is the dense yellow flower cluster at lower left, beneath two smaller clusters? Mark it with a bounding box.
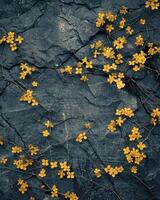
[13,155,33,171]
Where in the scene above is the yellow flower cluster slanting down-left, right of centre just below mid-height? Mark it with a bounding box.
[107,107,134,133]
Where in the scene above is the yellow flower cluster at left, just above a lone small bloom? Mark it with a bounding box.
[19,63,36,79]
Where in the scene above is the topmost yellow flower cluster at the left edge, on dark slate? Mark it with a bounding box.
[0,32,23,51]
